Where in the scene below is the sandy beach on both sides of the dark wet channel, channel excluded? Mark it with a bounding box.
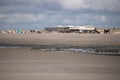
[0,33,120,80]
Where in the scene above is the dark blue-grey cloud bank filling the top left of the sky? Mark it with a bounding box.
[0,0,61,14]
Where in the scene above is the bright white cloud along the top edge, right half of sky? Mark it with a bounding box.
[60,0,120,11]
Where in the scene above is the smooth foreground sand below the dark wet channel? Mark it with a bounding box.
[0,48,120,80]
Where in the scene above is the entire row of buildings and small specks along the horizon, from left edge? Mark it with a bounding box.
[0,25,111,34]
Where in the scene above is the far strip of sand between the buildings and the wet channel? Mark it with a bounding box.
[0,33,120,46]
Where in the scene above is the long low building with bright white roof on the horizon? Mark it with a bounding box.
[45,25,110,33]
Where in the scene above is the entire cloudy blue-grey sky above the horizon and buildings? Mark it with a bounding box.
[0,0,120,29]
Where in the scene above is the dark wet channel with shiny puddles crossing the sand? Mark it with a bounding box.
[0,44,120,55]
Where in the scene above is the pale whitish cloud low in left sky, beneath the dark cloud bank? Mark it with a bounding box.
[6,14,45,23]
